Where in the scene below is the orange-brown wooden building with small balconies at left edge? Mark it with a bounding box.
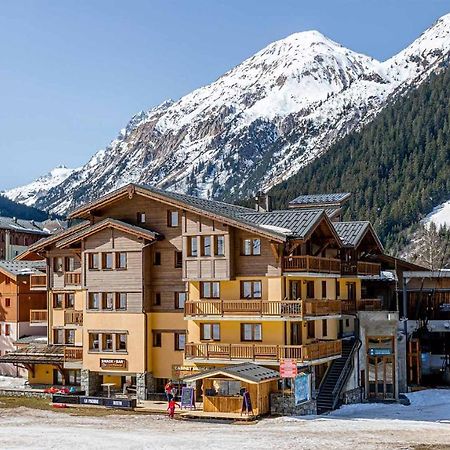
[0,261,47,376]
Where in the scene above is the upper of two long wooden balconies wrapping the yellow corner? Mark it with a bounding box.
[184,299,341,320]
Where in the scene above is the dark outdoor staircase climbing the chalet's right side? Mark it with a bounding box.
[317,337,356,414]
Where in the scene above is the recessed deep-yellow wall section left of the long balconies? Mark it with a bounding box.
[147,312,187,378]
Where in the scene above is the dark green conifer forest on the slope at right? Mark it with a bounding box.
[270,65,450,253]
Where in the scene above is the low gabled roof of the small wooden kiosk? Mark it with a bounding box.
[184,363,280,384]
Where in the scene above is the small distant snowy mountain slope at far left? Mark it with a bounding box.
[2,166,75,206]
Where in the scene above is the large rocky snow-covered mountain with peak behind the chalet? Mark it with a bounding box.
[11,14,450,213]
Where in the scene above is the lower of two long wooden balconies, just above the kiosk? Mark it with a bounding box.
[185,340,342,364]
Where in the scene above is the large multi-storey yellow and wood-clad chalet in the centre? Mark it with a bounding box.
[0,184,422,413]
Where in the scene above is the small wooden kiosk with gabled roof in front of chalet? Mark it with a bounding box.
[184,363,280,416]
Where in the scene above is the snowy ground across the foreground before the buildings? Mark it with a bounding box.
[0,390,450,450]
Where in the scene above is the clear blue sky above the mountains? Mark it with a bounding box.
[0,0,450,190]
